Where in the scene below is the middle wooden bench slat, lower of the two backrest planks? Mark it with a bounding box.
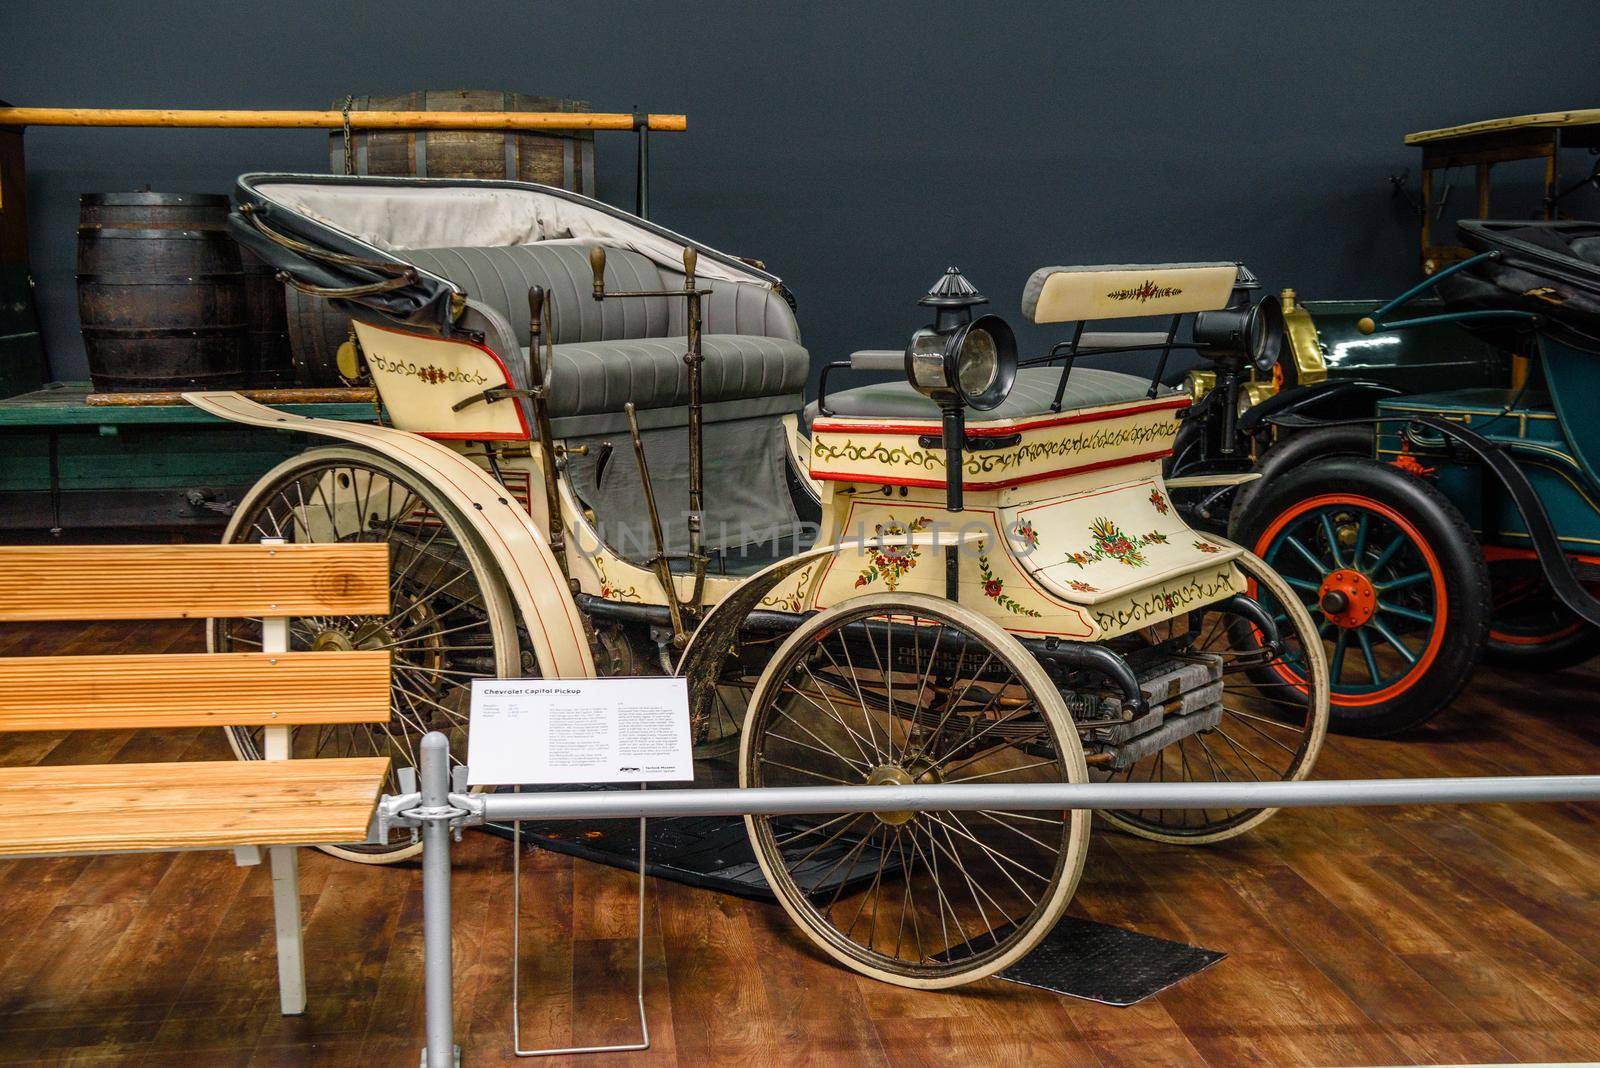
[0,649,389,732]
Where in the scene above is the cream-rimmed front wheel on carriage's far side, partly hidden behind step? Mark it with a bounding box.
[1094,553,1328,846]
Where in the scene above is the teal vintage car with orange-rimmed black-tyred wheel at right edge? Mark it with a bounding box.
[1234,221,1600,734]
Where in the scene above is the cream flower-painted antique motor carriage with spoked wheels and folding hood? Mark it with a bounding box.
[187,174,1328,986]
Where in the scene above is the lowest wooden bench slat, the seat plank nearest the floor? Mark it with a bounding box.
[0,756,389,857]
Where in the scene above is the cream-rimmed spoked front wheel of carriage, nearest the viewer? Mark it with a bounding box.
[739,593,1090,988]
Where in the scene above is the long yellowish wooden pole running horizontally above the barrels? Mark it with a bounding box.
[0,107,688,131]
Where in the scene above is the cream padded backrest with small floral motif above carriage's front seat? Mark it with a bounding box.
[1022,264,1238,323]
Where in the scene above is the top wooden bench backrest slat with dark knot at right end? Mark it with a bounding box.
[0,542,389,622]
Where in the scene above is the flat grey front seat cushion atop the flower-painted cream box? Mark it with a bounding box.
[802,368,1171,430]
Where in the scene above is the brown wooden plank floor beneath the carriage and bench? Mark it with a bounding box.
[0,624,1600,1068]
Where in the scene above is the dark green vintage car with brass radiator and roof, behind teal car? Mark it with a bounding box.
[1166,110,1600,684]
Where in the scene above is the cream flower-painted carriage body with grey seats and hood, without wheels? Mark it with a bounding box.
[232,176,1243,641]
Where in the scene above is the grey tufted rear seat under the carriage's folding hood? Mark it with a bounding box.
[405,241,810,417]
